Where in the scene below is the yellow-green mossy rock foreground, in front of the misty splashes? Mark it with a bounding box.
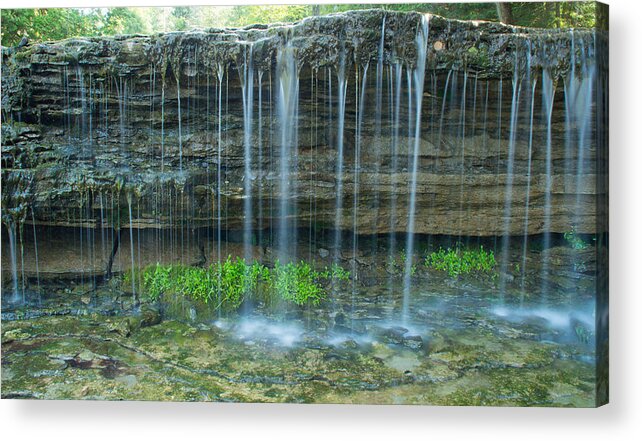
[2,304,593,406]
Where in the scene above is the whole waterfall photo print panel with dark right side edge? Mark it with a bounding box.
[2,2,608,407]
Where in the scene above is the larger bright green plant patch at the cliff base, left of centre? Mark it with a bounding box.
[132,257,350,310]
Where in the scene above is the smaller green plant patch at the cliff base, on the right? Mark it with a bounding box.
[424,246,497,277]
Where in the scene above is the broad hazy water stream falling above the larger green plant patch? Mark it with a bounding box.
[277,42,299,261]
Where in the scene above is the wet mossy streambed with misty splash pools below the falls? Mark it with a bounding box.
[2,268,595,407]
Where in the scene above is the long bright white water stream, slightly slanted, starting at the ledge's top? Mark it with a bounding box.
[401,16,428,323]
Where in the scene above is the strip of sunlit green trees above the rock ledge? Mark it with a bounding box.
[1,2,600,46]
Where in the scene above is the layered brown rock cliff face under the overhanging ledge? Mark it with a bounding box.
[2,11,599,236]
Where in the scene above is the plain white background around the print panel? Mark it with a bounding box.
[0,0,642,441]
